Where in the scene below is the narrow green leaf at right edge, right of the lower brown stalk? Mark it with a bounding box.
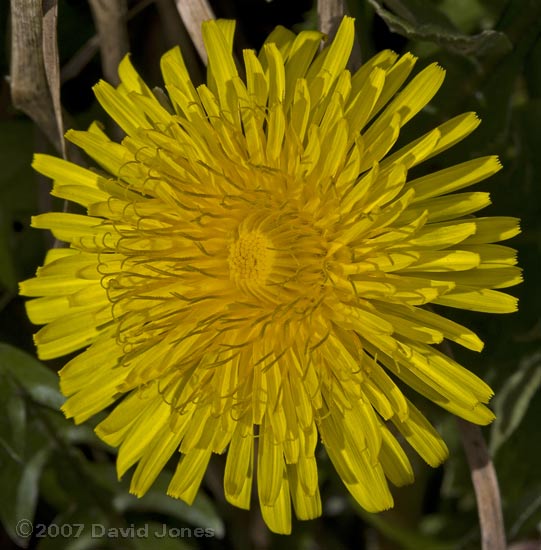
[490,351,541,454]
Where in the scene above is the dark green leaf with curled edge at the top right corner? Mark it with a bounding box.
[369,0,512,57]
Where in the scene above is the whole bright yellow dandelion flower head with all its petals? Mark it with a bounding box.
[21,18,521,533]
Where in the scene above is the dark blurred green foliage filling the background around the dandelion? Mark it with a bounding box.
[0,0,541,550]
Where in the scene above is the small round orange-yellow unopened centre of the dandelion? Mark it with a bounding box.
[228,230,273,285]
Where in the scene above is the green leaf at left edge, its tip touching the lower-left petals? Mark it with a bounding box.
[0,343,64,410]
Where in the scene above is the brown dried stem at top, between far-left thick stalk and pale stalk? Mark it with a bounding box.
[89,0,129,85]
